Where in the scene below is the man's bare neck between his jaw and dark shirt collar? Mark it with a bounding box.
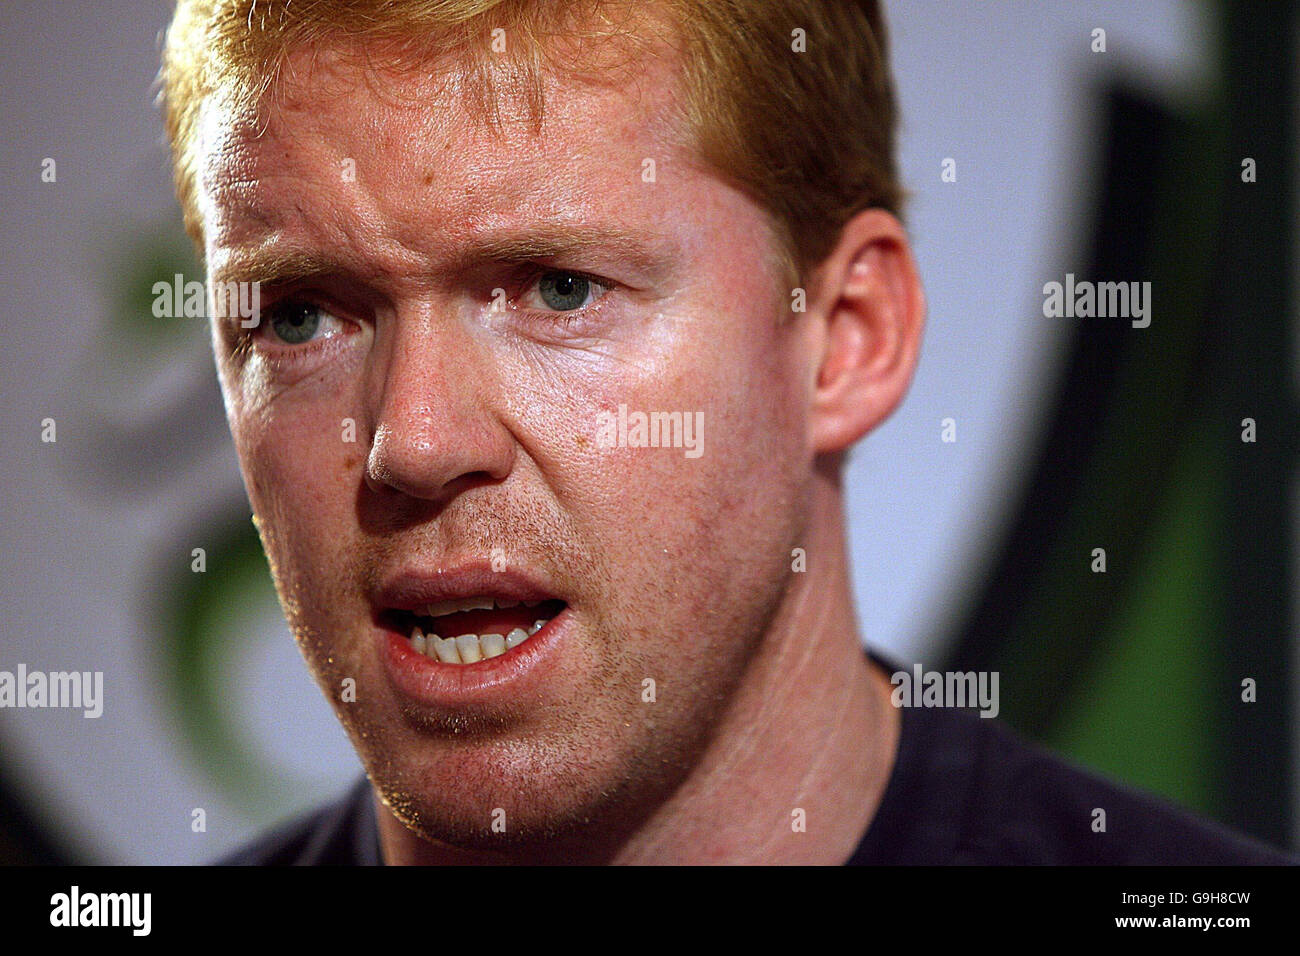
[376,472,900,865]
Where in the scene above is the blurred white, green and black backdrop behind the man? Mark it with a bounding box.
[0,0,1300,864]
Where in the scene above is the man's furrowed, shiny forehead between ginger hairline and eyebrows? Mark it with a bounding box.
[200,29,716,274]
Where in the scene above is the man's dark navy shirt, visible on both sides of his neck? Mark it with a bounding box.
[220,660,1300,866]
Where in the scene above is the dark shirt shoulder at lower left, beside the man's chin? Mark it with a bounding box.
[215,777,378,866]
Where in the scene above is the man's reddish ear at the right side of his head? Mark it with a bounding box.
[809,209,926,454]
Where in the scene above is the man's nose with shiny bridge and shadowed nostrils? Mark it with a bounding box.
[365,320,516,502]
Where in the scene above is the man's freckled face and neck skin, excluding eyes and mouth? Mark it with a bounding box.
[202,33,915,862]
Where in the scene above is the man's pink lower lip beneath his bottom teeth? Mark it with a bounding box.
[376,607,568,708]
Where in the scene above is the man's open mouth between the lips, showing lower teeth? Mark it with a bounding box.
[381,594,567,665]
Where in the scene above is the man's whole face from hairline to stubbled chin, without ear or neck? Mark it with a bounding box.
[202,33,811,847]
